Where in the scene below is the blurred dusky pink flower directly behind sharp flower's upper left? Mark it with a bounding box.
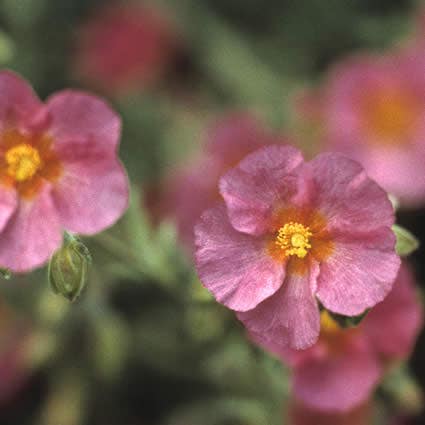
[162,112,283,248]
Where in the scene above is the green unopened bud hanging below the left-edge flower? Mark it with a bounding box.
[48,233,91,301]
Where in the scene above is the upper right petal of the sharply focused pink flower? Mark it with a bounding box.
[307,153,394,233]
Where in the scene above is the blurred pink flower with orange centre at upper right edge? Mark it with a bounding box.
[306,48,425,206]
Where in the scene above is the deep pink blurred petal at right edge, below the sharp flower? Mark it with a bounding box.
[362,264,423,358]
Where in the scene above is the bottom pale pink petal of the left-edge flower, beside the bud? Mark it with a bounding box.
[0,185,62,272]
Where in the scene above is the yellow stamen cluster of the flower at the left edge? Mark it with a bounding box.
[5,143,42,182]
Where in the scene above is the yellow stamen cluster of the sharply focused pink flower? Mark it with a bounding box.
[275,221,313,258]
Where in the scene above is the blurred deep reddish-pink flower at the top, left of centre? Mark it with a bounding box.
[76,4,180,93]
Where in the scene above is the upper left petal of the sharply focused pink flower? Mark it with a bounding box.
[220,145,303,234]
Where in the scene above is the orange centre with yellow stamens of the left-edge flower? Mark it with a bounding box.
[0,130,62,199]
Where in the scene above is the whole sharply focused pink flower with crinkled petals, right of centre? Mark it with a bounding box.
[195,146,400,349]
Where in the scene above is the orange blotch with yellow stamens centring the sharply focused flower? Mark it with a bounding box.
[267,208,333,274]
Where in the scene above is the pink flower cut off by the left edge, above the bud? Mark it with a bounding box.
[0,71,128,272]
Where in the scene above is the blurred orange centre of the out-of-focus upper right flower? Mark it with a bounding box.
[363,88,420,145]
